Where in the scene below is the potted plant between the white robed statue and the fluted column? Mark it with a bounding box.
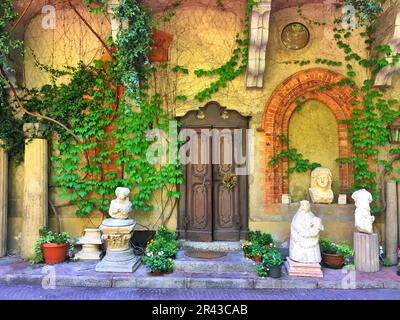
[319,237,354,269]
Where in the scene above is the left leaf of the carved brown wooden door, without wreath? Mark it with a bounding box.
[185,129,213,241]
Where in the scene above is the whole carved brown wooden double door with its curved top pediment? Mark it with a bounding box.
[178,102,248,241]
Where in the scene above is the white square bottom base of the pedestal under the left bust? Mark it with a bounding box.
[96,248,140,272]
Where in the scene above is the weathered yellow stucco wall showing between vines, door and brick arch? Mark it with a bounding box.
[9,0,394,252]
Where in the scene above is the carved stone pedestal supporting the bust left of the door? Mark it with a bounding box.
[96,219,140,272]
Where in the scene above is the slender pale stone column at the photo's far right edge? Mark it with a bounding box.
[385,181,398,264]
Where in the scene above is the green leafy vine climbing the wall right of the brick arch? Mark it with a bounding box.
[292,0,400,212]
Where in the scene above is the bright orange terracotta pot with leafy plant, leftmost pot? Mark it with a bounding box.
[31,228,73,264]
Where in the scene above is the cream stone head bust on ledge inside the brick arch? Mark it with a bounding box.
[308,168,333,203]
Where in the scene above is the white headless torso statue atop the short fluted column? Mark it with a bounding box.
[351,189,375,234]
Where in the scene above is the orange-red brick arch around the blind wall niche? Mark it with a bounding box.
[262,68,360,203]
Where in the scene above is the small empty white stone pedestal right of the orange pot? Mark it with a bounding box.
[75,229,103,260]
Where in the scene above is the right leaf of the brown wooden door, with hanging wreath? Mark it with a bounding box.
[213,129,241,241]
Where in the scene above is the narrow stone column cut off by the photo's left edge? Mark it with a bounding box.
[0,141,8,257]
